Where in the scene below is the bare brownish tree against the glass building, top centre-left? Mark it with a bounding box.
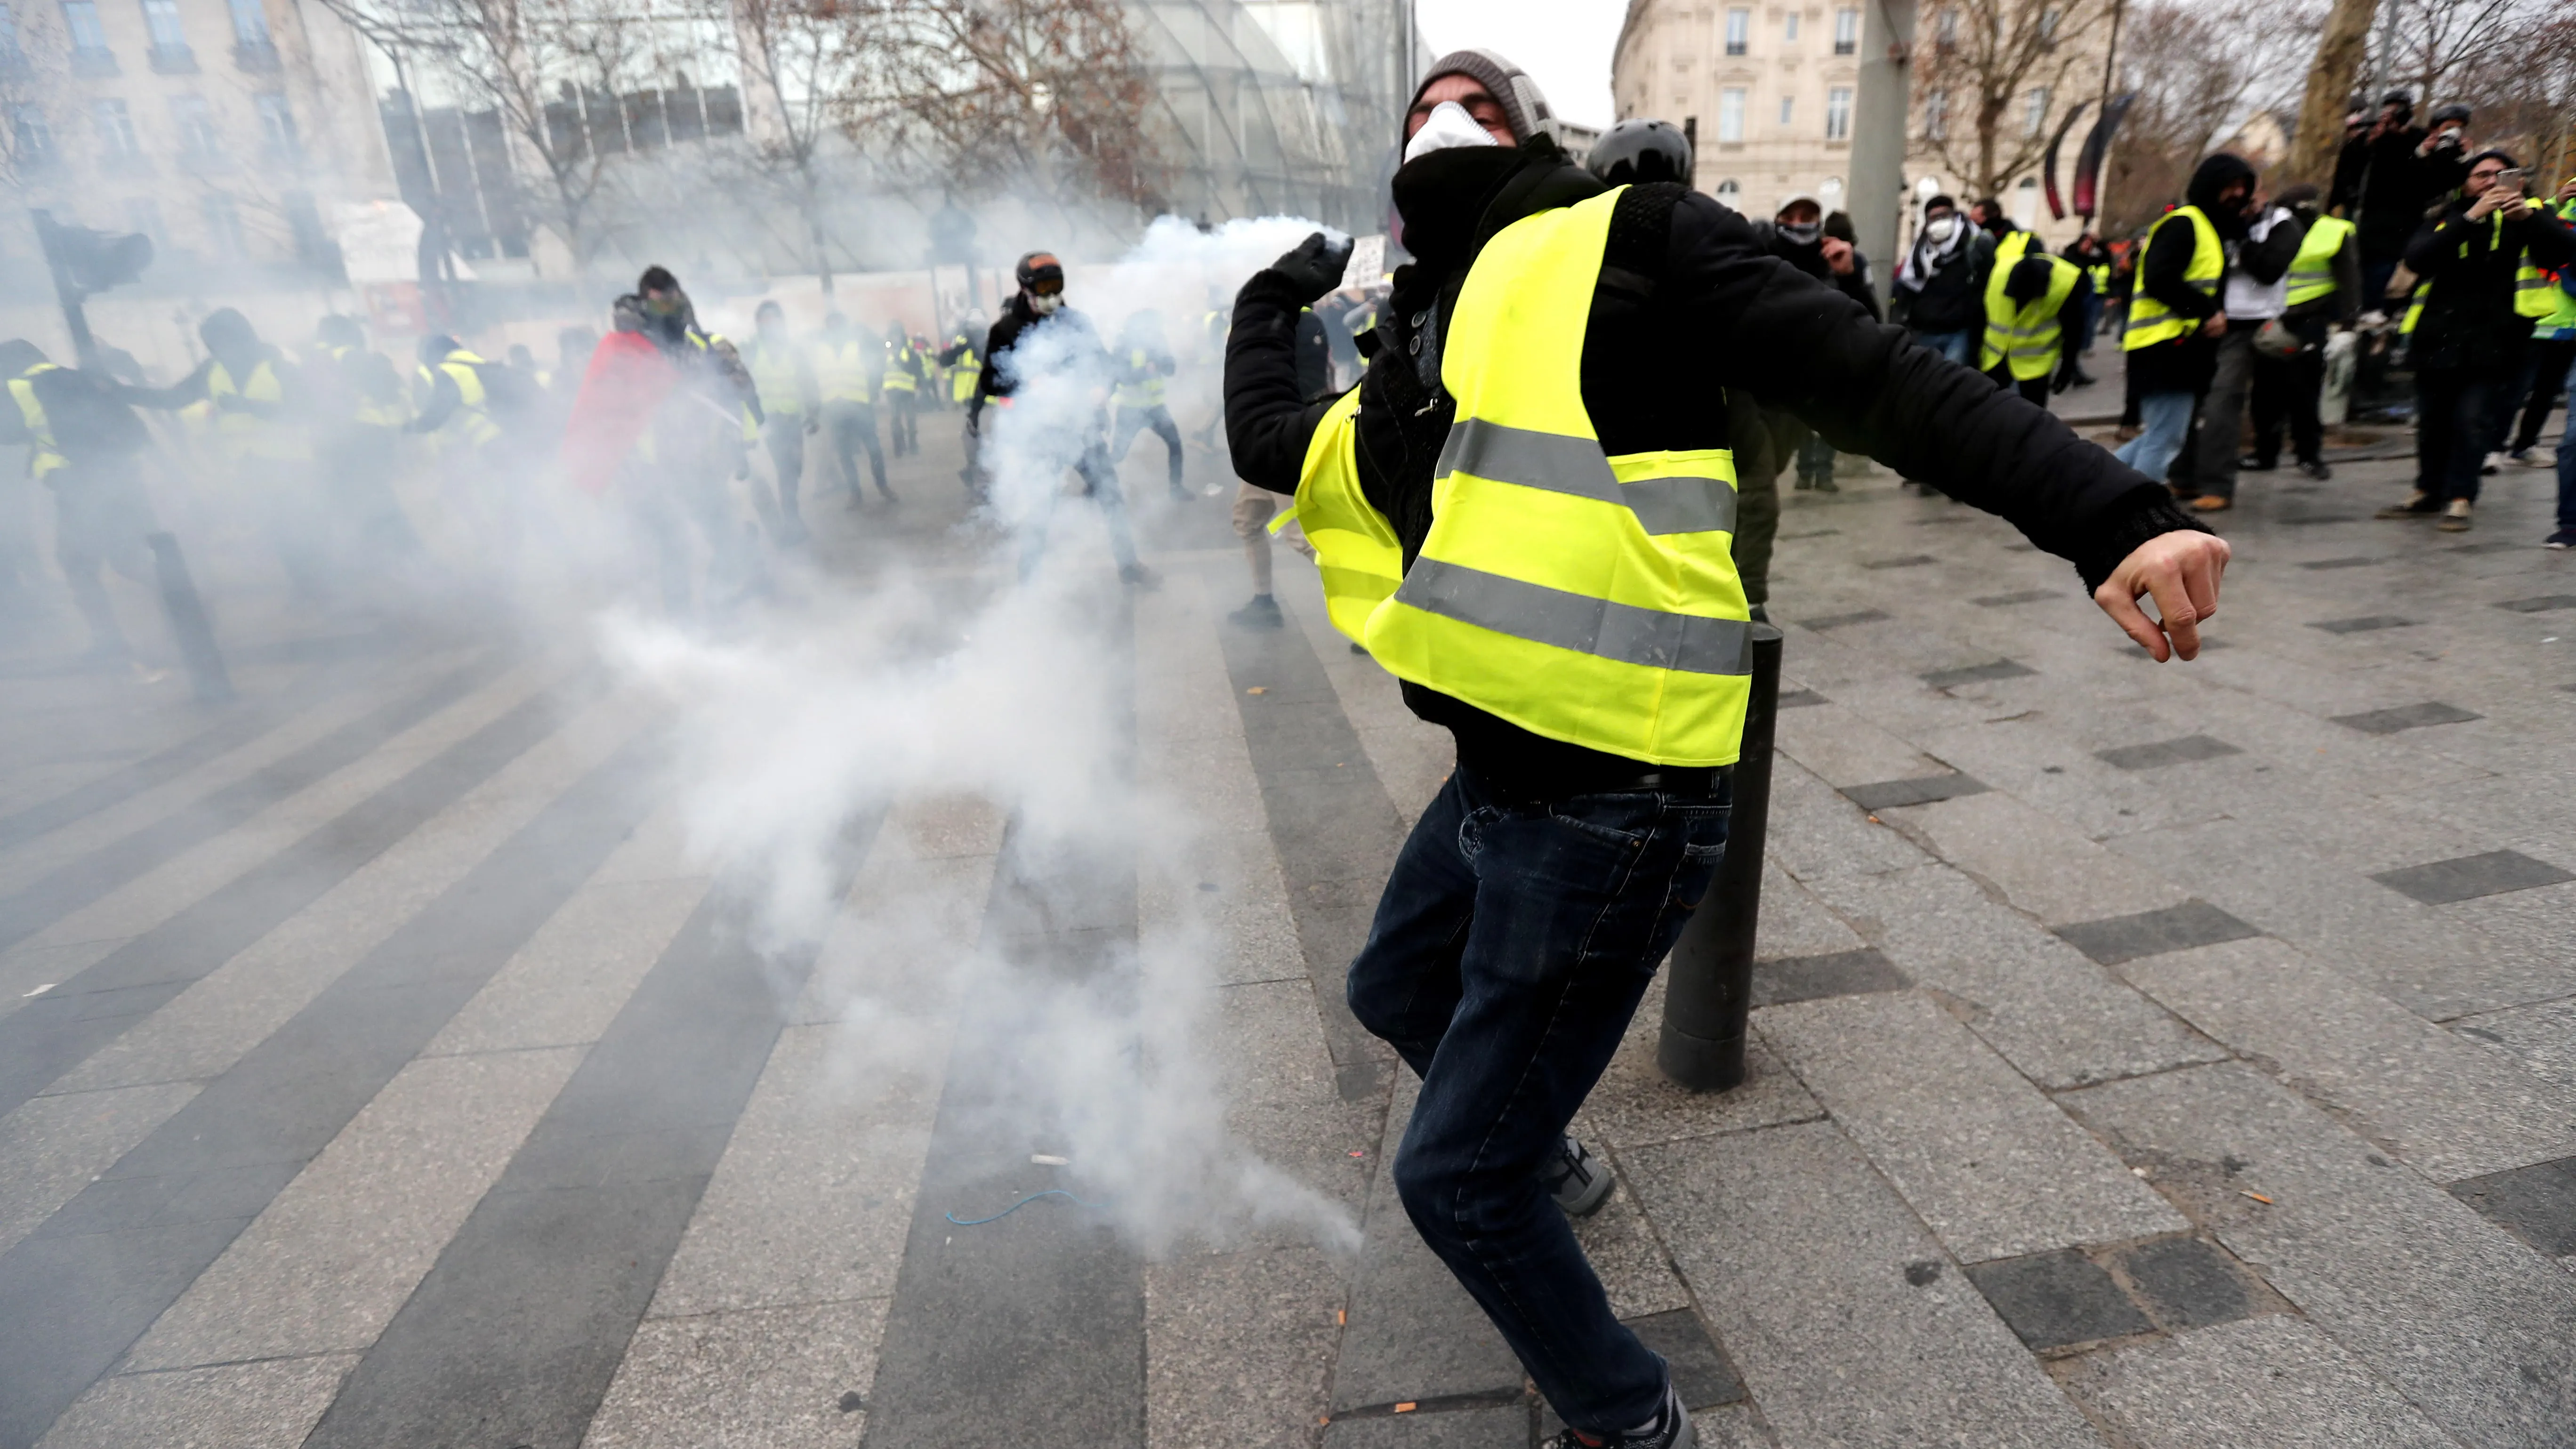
[842,0,1164,211]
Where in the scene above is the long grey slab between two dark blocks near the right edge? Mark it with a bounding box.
[2115,820,2576,1021]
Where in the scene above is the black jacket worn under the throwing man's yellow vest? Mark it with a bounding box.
[1226,142,2198,794]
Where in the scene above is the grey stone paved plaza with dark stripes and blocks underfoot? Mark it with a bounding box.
[0,418,2576,1449]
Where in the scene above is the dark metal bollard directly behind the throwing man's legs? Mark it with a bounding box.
[1654,624,1780,1091]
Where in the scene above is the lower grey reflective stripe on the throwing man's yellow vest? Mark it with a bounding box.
[1396,554,1752,673]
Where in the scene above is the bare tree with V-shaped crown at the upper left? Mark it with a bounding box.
[322,0,657,274]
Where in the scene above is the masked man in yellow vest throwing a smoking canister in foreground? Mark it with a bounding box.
[1226,52,2228,1449]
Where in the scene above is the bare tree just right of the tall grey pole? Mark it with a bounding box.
[1914,0,2112,196]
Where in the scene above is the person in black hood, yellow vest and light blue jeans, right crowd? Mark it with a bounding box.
[2120,152,2254,480]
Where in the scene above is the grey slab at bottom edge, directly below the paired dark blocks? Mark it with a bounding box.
[2066,1315,2457,1449]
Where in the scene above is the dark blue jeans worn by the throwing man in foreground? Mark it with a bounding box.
[1350,766,1729,1433]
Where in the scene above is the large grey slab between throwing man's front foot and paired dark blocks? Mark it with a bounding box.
[1636,1121,2097,1449]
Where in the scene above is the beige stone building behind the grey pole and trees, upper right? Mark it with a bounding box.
[1610,0,2100,245]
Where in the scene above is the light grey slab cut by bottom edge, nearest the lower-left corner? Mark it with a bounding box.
[41,1353,358,1449]
